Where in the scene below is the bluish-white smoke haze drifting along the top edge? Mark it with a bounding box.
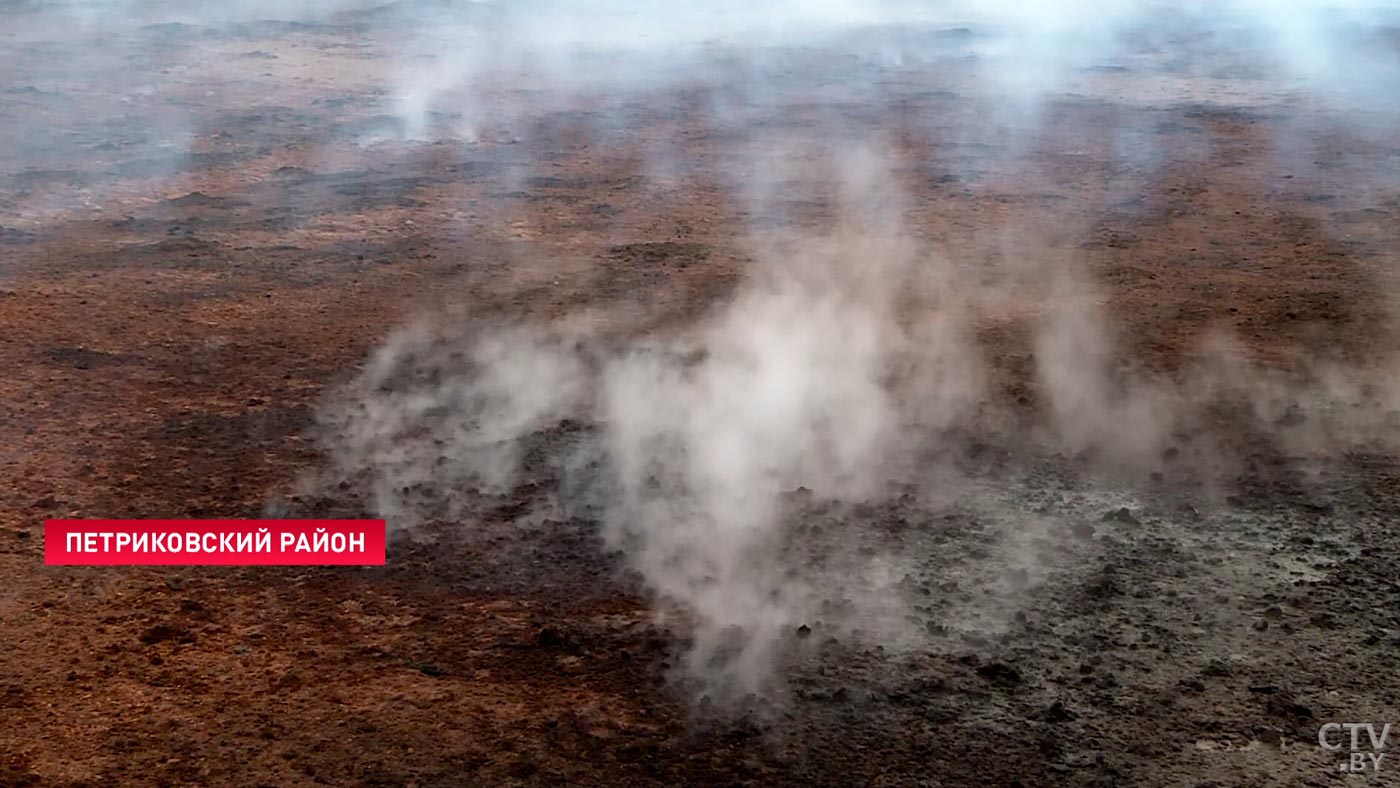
[6,0,1400,179]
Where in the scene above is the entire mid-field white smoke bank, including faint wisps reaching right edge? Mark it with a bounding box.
[315,134,1400,701]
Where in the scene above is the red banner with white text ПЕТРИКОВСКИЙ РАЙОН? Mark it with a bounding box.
[43,519,386,567]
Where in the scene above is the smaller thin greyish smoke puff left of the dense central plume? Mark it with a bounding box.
[326,323,588,523]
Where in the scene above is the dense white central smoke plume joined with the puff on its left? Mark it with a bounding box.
[325,154,984,700]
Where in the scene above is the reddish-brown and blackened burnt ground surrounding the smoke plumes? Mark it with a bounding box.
[0,7,1400,788]
